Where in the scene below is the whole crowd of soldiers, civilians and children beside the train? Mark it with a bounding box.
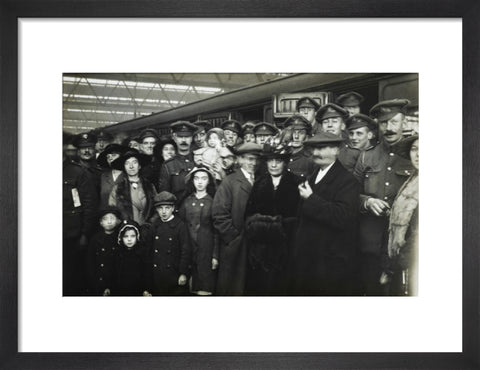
[63,92,419,296]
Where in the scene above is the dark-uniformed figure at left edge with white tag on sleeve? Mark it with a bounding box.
[63,133,97,296]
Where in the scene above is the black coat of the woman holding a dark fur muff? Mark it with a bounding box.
[245,171,300,295]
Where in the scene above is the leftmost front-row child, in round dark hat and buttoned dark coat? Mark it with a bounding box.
[87,207,122,296]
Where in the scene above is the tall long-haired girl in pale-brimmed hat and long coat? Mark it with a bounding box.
[179,167,218,295]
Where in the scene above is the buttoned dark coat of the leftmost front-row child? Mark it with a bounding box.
[87,230,118,295]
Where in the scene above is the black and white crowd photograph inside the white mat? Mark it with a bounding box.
[62,72,422,297]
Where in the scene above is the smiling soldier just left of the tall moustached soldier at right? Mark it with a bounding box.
[338,113,377,172]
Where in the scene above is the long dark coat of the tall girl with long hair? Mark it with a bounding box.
[179,194,219,293]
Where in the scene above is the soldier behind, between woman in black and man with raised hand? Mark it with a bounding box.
[283,114,313,181]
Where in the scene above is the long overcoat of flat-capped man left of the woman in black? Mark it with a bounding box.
[212,169,252,295]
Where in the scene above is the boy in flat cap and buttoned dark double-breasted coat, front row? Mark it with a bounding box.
[147,191,191,295]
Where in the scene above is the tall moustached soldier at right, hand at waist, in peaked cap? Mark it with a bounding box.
[353,99,413,295]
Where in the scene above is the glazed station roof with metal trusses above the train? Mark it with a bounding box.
[63,73,290,133]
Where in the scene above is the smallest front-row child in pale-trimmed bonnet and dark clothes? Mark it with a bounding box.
[113,221,150,296]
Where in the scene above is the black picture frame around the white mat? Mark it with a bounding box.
[0,0,480,370]
